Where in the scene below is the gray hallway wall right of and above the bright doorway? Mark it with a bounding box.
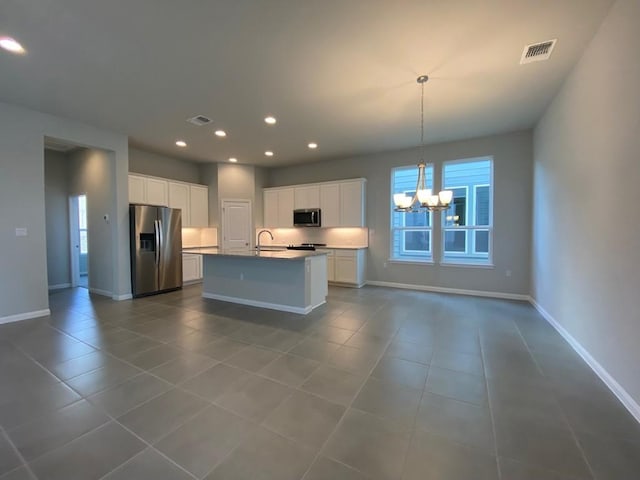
[69,148,113,294]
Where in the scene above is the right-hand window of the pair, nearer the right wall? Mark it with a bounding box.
[442,158,493,265]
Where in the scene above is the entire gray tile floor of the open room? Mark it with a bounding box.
[0,286,640,480]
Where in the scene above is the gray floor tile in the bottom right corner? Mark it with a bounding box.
[578,434,640,480]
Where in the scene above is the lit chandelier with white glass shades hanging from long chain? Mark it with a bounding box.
[393,75,453,212]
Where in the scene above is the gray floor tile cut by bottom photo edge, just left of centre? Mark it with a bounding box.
[206,428,315,480]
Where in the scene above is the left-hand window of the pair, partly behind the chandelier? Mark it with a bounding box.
[391,165,433,262]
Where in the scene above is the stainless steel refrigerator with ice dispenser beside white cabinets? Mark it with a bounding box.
[129,205,182,297]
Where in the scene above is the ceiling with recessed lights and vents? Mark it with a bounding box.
[0,0,613,165]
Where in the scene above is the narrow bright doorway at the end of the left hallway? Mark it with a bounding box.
[69,194,89,289]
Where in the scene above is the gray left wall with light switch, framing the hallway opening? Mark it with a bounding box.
[0,99,131,322]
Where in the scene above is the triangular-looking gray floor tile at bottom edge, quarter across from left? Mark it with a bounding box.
[103,448,192,480]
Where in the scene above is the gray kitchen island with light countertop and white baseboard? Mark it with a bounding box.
[184,248,328,315]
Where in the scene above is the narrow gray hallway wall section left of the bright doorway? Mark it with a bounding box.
[44,150,71,287]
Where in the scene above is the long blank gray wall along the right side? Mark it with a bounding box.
[532,0,640,404]
